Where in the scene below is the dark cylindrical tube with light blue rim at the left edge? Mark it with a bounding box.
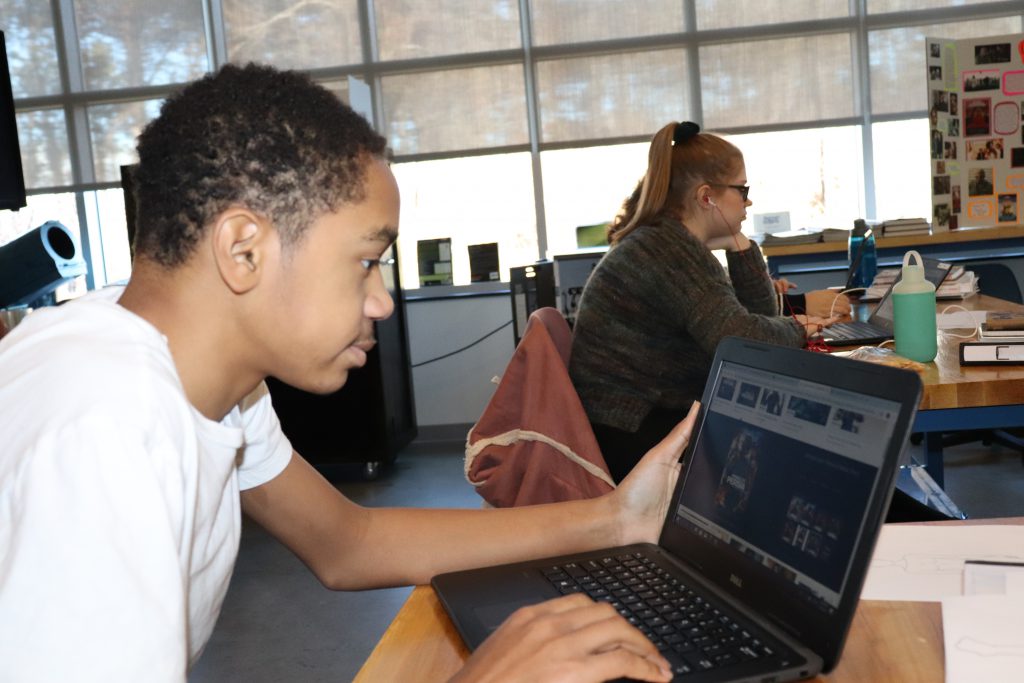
[0,220,88,308]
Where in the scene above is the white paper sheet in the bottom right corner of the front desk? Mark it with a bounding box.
[942,595,1024,683]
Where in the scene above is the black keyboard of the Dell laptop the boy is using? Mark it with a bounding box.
[543,553,776,674]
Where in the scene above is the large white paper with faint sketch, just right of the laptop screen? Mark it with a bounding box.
[860,524,1024,602]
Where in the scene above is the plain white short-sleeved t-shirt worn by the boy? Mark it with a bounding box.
[0,288,292,682]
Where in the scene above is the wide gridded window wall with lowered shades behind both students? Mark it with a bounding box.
[8,0,1024,288]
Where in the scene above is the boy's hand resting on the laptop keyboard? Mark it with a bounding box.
[451,593,672,683]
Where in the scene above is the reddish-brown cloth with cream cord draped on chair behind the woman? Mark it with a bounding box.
[465,307,615,507]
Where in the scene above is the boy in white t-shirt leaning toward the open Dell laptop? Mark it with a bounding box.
[0,65,692,683]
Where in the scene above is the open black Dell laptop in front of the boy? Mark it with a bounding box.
[432,338,922,682]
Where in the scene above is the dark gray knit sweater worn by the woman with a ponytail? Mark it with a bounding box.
[569,218,805,432]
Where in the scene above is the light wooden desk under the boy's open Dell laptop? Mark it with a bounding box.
[354,517,1024,683]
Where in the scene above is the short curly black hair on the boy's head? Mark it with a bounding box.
[132,63,386,267]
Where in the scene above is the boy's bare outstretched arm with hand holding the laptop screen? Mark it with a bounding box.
[242,409,695,589]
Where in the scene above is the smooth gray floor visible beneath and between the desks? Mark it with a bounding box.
[188,442,1024,683]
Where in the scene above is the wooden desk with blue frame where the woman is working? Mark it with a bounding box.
[839,294,1024,486]
